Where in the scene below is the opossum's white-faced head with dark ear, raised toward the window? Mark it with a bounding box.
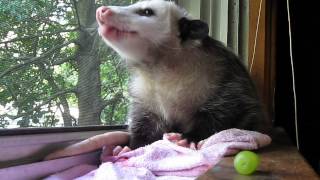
[96,0,208,64]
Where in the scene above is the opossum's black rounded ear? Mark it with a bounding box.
[178,17,209,41]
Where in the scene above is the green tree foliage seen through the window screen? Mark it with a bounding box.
[0,0,133,128]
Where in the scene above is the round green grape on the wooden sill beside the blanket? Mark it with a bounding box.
[233,151,260,175]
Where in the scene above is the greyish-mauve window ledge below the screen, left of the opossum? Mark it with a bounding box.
[0,126,127,168]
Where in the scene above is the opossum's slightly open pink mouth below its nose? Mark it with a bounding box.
[99,24,138,40]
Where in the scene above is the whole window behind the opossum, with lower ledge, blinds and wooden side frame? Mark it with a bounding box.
[0,0,273,172]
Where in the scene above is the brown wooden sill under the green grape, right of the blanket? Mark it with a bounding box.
[198,129,319,180]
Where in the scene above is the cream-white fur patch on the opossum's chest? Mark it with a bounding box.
[131,64,211,121]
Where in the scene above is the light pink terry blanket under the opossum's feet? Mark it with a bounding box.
[45,129,271,180]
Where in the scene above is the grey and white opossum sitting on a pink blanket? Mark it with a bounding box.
[96,0,268,149]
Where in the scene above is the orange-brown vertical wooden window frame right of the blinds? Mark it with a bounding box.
[248,0,277,121]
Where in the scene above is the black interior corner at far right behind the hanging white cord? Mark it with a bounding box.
[274,0,320,174]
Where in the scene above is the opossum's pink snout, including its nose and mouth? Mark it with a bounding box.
[96,6,137,41]
